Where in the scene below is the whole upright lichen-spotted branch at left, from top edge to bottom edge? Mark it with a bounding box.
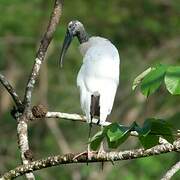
[15,0,62,180]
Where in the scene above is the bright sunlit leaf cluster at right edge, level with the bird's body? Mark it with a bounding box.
[133,64,180,97]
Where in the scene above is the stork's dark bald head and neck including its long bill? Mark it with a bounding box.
[59,20,89,66]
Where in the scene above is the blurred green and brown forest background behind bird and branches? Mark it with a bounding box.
[0,0,180,180]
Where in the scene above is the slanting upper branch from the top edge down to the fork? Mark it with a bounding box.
[24,0,62,108]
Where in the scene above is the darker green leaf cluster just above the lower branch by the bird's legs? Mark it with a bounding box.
[90,118,175,150]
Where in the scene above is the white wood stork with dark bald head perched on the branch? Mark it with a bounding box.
[59,20,120,157]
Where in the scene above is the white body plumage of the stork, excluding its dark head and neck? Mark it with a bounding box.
[77,37,120,124]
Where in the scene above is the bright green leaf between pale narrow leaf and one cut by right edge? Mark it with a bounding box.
[141,64,167,96]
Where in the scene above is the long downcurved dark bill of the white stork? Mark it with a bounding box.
[59,30,73,67]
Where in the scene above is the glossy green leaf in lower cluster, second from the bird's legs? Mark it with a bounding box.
[106,123,130,148]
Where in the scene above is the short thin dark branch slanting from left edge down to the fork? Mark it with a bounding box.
[0,74,22,107]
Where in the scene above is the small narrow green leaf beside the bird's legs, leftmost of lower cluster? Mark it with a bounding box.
[90,131,105,151]
